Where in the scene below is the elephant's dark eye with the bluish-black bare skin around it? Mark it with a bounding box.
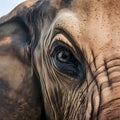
[51,42,85,79]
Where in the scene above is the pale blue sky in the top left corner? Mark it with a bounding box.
[0,0,25,17]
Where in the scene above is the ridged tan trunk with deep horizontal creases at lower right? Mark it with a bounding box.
[96,58,120,120]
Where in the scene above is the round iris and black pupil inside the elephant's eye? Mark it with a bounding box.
[58,50,70,62]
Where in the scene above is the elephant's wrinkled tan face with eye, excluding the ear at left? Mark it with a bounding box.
[33,0,120,120]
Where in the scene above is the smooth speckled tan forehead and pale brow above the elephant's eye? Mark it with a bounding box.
[52,0,120,59]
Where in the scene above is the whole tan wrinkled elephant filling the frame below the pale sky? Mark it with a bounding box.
[0,0,120,120]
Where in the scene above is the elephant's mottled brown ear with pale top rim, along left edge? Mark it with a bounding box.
[0,0,44,120]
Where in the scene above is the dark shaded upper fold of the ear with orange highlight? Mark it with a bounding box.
[0,17,30,62]
